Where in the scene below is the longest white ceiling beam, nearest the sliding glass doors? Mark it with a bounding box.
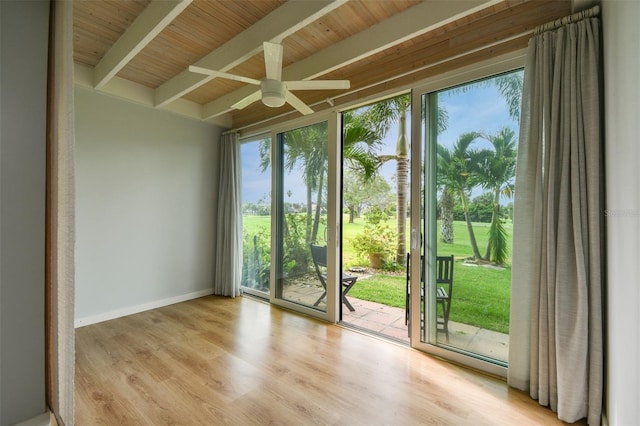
[203,0,498,119]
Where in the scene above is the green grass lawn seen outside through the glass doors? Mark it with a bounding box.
[244,216,511,333]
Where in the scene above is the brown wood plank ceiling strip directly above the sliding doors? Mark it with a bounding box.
[233,1,571,132]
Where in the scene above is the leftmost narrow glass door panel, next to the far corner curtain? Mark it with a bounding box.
[240,136,271,299]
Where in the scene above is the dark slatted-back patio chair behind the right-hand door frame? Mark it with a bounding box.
[405,253,453,338]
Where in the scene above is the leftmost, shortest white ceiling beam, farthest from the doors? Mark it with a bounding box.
[93,0,192,89]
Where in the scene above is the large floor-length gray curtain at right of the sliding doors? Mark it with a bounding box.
[508,10,604,424]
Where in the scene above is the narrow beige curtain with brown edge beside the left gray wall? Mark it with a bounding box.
[45,1,75,425]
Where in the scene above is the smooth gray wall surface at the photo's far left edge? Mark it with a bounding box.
[0,0,49,425]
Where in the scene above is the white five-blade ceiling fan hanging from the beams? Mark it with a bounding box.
[189,41,350,115]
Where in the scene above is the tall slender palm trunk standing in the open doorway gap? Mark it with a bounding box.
[396,110,409,266]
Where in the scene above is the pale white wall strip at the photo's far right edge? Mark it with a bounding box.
[602,0,640,425]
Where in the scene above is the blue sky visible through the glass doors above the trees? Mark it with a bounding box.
[241,75,518,203]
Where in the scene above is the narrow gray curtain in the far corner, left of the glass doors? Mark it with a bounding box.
[213,133,242,297]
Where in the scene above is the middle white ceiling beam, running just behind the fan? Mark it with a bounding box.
[156,0,347,107]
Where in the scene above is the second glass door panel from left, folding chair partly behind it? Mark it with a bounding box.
[275,122,328,312]
